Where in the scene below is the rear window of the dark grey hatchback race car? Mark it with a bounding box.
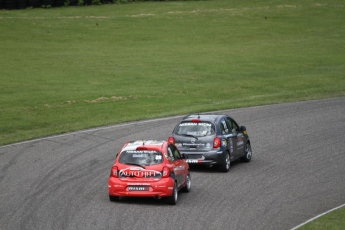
[176,122,215,137]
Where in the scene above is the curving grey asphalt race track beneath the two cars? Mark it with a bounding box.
[0,98,345,230]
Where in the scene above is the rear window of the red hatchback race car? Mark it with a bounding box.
[119,150,163,166]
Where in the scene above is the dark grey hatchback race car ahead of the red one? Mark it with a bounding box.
[168,114,252,172]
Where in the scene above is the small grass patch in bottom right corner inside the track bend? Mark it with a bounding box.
[298,208,345,230]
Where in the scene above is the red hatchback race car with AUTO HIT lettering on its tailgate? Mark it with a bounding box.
[108,140,191,205]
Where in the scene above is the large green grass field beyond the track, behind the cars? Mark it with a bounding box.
[0,0,345,145]
